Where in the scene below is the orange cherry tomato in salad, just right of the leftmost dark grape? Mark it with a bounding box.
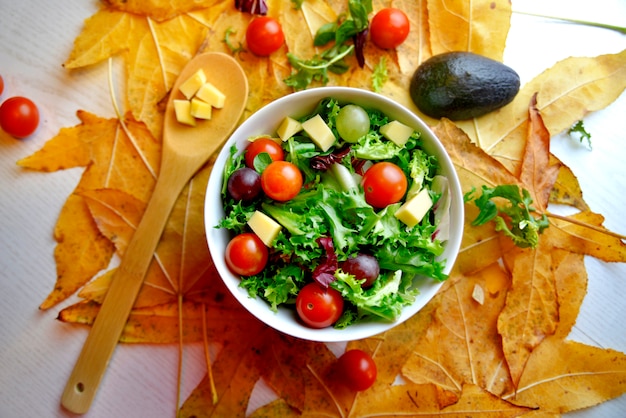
[261,161,303,202]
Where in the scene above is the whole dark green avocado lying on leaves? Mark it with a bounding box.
[409,51,520,120]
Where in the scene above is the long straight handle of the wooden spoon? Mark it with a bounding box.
[61,170,185,414]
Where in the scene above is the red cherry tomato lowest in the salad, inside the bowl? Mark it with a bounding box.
[296,283,343,328]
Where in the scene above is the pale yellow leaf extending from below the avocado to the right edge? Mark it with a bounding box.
[457,51,626,173]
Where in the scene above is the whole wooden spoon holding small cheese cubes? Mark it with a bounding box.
[61,52,248,414]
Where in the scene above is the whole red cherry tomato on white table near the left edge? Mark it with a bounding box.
[0,96,39,138]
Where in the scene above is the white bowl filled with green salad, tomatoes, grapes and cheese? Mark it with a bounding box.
[205,87,463,341]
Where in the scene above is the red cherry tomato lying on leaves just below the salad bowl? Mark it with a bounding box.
[335,349,378,391]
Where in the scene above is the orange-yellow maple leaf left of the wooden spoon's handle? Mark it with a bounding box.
[18,111,161,309]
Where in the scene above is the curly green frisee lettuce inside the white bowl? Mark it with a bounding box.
[219,98,447,327]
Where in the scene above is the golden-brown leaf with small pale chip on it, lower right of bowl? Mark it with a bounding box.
[402,263,512,395]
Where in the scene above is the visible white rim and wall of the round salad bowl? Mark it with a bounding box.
[204,87,463,342]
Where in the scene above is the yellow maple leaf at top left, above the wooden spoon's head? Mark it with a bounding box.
[64,7,208,138]
